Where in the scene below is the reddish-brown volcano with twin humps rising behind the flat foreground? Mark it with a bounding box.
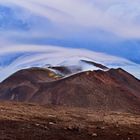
[0,68,140,112]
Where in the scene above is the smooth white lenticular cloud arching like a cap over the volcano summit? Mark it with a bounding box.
[0,45,137,81]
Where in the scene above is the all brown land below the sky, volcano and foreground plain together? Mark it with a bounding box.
[0,65,140,140]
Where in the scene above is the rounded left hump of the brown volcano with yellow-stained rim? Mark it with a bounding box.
[0,68,61,101]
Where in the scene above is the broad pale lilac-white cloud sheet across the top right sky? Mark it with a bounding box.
[0,0,140,38]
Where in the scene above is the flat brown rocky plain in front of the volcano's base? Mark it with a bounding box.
[0,102,140,140]
